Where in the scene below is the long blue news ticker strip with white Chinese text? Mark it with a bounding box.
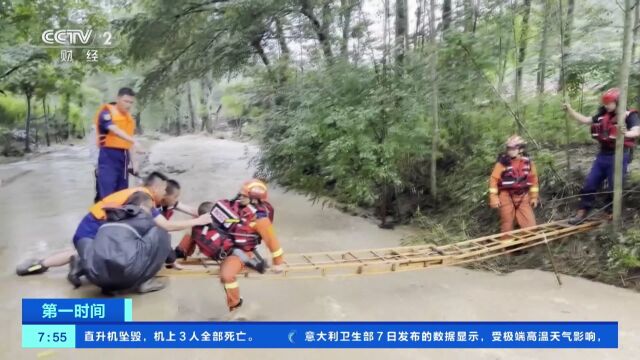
[62,322,618,349]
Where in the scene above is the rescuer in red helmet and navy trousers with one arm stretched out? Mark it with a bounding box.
[564,88,640,225]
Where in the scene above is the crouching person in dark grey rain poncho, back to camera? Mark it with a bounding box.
[70,191,175,294]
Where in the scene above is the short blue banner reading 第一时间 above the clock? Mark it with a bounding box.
[22,299,132,324]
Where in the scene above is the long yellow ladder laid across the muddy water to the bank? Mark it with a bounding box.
[158,220,604,279]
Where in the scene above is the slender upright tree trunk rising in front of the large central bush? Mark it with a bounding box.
[429,0,440,202]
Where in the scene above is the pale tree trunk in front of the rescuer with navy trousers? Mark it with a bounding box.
[613,0,633,232]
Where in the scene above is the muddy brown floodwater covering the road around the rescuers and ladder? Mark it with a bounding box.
[0,136,640,360]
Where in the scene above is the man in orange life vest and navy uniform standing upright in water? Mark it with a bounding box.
[94,88,142,200]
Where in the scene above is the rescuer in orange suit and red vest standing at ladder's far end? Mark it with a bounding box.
[489,135,540,235]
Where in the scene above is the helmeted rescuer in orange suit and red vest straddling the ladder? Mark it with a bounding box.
[176,179,284,312]
